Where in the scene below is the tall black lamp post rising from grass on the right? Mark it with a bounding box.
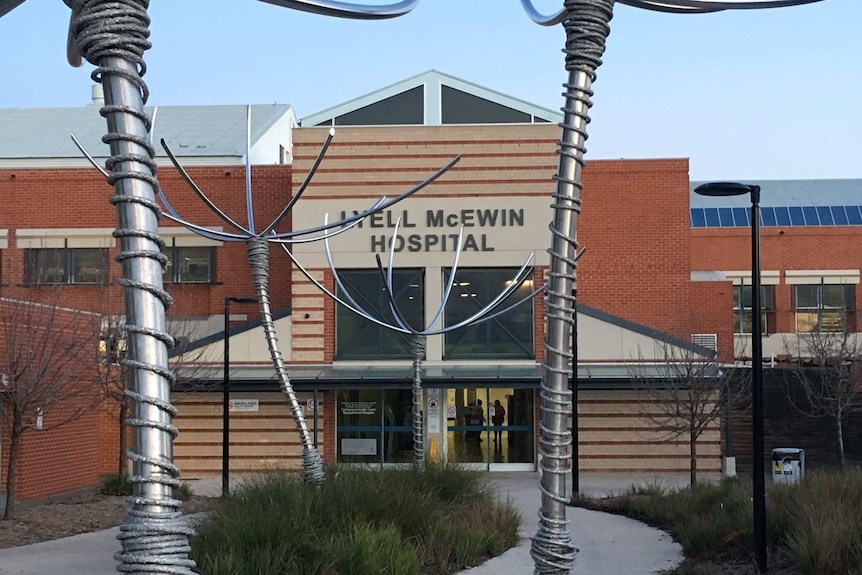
[694,182,767,573]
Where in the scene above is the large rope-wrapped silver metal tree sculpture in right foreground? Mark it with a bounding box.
[521,0,832,575]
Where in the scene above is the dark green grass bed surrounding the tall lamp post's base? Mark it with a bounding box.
[573,472,862,575]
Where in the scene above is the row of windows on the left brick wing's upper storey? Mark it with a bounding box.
[24,247,215,285]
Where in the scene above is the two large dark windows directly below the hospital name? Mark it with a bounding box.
[335,268,535,360]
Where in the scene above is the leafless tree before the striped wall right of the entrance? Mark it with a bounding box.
[629,341,748,485]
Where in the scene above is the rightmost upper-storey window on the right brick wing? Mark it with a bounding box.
[793,284,856,333]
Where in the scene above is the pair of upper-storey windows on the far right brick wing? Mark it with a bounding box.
[733,284,856,333]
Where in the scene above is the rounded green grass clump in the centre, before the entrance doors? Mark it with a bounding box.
[192,466,521,575]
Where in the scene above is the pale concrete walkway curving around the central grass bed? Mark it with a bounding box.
[0,473,687,575]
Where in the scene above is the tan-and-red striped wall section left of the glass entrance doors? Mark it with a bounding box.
[172,391,324,479]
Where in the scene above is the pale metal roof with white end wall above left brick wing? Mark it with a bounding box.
[0,104,295,167]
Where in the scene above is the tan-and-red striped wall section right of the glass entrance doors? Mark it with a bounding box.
[569,390,721,473]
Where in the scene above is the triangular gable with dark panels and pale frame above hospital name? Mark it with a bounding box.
[299,70,563,127]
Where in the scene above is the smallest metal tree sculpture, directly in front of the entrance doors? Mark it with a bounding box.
[282,220,545,472]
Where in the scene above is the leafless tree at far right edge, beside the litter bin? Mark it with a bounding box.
[785,328,862,472]
